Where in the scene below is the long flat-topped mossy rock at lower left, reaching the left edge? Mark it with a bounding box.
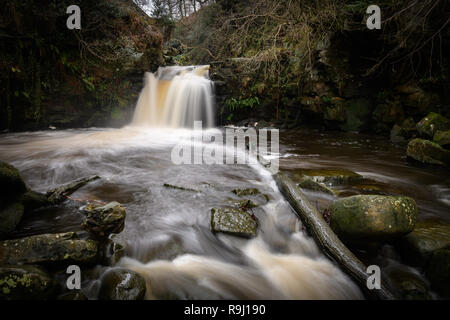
[0,232,98,265]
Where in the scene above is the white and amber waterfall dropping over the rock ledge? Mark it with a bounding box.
[132,66,215,128]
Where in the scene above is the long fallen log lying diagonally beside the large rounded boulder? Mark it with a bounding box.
[275,173,395,299]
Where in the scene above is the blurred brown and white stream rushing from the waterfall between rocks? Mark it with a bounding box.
[0,69,450,299]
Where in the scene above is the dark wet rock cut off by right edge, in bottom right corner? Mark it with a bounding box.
[425,248,450,298]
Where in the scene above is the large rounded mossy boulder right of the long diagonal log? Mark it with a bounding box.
[330,195,418,242]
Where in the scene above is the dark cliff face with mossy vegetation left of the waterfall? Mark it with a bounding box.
[0,0,162,130]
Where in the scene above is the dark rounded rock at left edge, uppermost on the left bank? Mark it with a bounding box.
[0,161,27,199]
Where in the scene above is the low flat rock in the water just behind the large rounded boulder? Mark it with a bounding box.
[293,169,363,185]
